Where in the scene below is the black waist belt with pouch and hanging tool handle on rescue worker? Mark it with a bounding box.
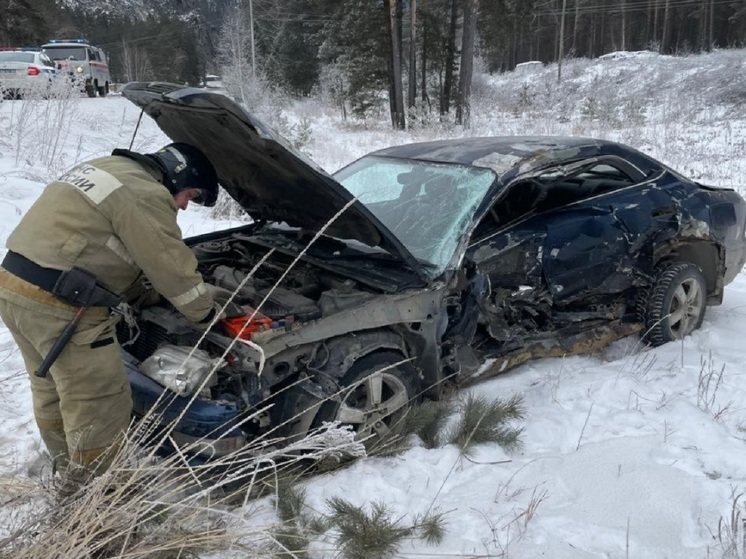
[2,251,122,378]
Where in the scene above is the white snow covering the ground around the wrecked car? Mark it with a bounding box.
[0,51,746,559]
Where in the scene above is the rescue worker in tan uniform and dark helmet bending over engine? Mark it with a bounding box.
[0,143,218,492]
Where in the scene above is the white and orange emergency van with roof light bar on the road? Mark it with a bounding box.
[42,39,111,97]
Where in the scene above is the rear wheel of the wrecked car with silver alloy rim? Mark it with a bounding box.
[641,262,707,346]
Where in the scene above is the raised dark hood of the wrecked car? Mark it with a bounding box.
[122,82,422,275]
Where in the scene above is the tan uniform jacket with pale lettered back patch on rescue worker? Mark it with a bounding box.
[7,156,213,322]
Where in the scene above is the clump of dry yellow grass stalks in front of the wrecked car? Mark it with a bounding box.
[0,418,363,559]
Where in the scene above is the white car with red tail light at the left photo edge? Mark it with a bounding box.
[0,48,57,98]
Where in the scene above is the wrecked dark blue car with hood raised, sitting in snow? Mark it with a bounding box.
[119,83,746,456]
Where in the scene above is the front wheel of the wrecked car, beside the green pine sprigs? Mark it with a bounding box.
[314,350,419,449]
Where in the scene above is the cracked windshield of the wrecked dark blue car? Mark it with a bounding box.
[334,157,495,273]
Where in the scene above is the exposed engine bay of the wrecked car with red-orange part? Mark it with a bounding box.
[118,234,396,438]
